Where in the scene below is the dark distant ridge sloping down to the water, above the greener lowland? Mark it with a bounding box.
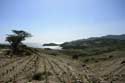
[61,35,125,49]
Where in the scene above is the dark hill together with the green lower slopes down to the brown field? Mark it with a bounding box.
[61,35,125,57]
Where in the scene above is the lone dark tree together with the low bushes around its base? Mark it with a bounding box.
[5,30,32,56]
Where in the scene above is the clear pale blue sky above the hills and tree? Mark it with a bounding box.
[0,0,125,43]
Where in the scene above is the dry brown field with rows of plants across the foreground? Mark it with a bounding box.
[0,49,125,83]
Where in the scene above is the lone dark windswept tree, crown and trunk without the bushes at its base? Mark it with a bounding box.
[6,30,31,54]
